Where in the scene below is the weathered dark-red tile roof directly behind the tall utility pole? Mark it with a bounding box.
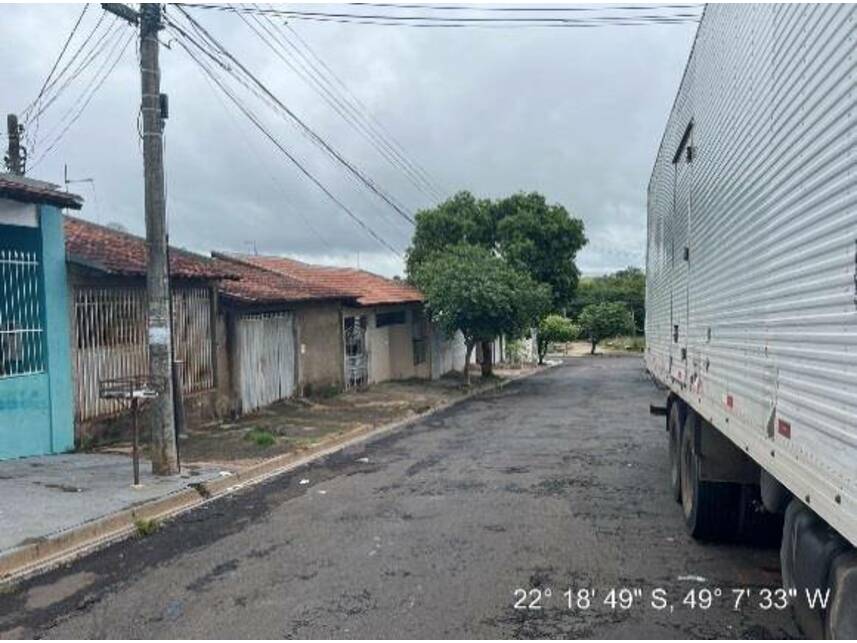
[65,216,235,279]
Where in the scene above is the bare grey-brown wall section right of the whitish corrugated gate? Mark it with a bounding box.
[295,303,345,395]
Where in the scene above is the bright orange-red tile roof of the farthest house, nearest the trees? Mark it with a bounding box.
[234,255,423,306]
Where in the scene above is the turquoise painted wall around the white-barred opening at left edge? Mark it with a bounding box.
[0,206,74,459]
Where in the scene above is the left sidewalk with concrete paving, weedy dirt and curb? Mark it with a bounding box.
[0,367,540,583]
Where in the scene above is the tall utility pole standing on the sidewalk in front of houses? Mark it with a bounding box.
[102,3,179,475]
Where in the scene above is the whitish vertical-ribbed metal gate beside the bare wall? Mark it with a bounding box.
[236,313,296,413]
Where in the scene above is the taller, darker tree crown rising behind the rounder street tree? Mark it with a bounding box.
[407,192,586,311]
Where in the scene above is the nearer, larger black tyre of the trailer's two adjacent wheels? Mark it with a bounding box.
[680,411,741,540]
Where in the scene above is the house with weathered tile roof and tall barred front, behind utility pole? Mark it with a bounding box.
[63,216,238,442]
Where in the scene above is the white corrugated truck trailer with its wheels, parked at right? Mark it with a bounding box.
[646,4,857,638]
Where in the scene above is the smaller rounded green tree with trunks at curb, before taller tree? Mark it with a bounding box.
[410,244,551,385]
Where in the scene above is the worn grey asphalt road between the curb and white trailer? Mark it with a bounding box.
[0,357,797,638]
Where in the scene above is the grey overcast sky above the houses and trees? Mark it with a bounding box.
[0,4,696,275]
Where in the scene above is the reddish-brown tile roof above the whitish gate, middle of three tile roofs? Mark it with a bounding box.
[212,252,350,304]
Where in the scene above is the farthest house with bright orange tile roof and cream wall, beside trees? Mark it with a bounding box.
[232,255,465,388]
